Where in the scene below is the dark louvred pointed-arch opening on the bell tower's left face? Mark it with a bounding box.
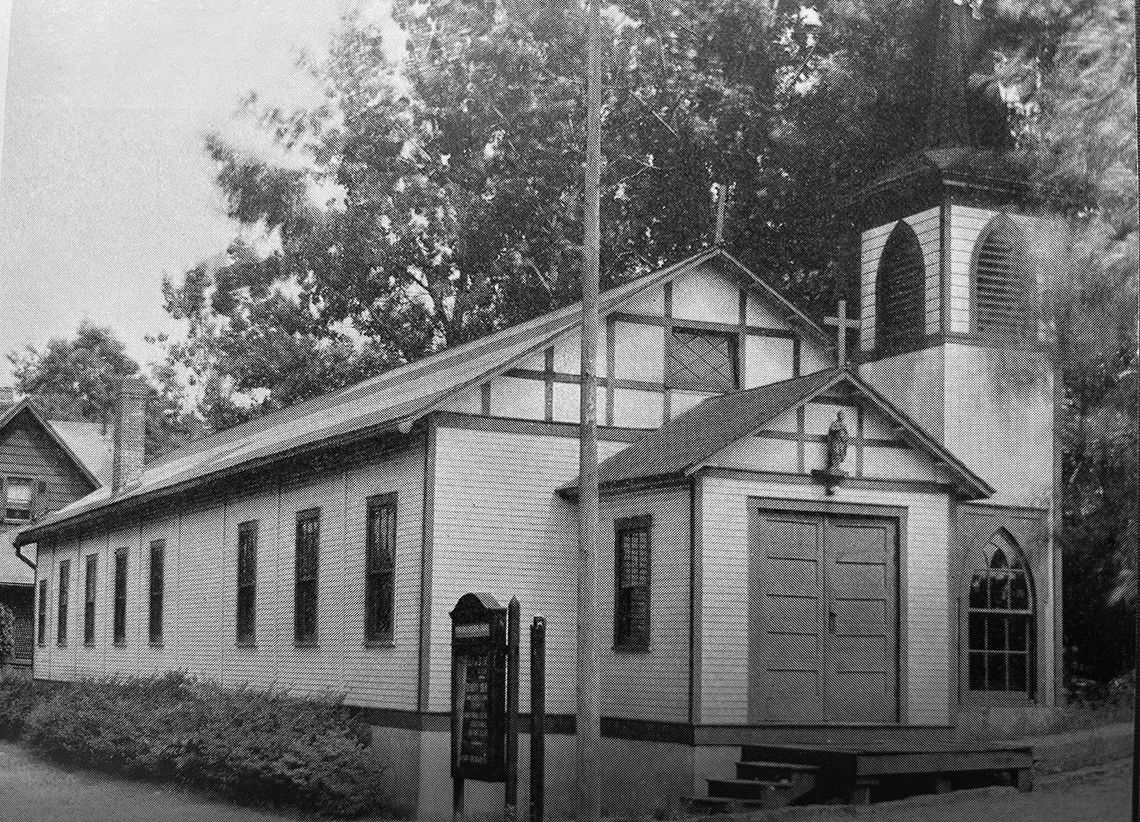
[876,220,926,352]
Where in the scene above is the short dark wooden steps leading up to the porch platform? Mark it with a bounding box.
[682,759,819,813]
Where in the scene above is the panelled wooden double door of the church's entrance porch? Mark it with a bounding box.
[749,507,899,724]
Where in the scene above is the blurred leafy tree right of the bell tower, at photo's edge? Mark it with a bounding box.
[999,0,1140,679]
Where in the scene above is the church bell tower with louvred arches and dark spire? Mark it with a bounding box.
[854,0,1055,507]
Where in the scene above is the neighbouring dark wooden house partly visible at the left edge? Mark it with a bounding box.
[0,389,111,668]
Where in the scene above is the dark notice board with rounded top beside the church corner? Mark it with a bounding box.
[451,594,506,782]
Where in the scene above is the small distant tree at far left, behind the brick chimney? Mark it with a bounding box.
[8,319,188,457]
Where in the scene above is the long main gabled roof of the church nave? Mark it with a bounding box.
[17,246,830,545]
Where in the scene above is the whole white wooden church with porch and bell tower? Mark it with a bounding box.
[17,4,1060,819]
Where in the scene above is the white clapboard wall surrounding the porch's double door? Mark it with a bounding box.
[701,477,951,725]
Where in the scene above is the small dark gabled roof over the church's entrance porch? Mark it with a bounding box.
[562,368,994,498]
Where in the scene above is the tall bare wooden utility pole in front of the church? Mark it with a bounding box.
[575,0,602,822]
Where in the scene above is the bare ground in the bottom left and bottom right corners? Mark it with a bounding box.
[0,742,1131,822]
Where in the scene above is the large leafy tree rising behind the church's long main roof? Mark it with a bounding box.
[165,0,948,426]
